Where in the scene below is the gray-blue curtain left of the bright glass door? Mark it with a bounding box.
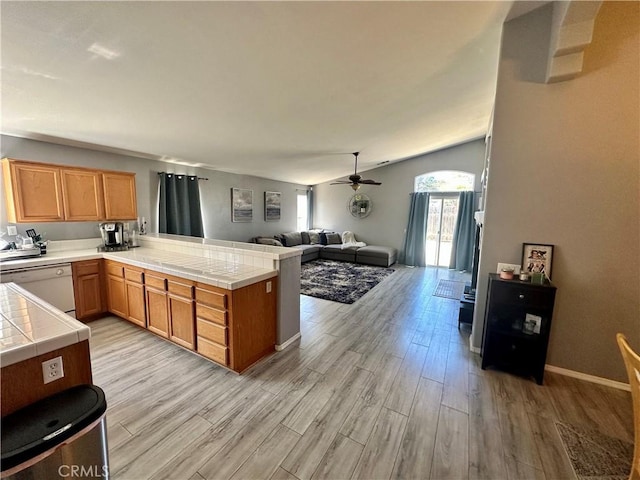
[400,192,429,267]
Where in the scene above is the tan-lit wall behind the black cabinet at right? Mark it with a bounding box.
[473,2,640,382]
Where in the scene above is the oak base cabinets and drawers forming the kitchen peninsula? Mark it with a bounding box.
[105,260,277,372]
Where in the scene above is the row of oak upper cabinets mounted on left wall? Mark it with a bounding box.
[2,158,138,223]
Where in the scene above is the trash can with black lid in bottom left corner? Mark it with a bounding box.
[1,385,109,480]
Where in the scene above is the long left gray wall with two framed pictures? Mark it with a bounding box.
[0,135,307,241]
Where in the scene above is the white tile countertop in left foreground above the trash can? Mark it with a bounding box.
[0,283,91,367]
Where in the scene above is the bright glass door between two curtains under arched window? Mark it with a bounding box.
[426,194,458,267]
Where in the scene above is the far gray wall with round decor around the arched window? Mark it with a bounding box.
[313,139,485,250]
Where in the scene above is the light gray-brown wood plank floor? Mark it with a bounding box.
[90,267,633,480]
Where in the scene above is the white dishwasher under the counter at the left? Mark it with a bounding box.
[0,263,76,317]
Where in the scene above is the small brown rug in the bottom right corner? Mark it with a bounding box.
[556,422,633,480]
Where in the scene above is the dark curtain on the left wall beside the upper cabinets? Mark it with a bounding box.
[158,172,204,237]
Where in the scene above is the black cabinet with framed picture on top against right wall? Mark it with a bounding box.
[482,273,556,385]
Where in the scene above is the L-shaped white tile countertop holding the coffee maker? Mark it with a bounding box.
[0,247,278,290]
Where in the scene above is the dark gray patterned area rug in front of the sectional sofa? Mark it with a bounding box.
[300,260,395,304]
